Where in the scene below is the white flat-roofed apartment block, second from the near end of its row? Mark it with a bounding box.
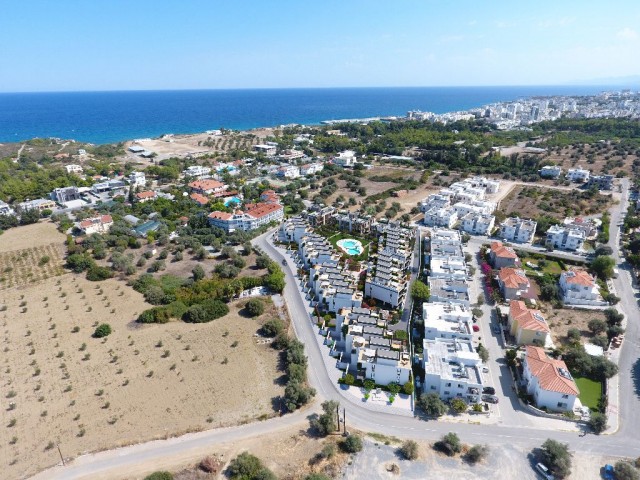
[422,302,473,340]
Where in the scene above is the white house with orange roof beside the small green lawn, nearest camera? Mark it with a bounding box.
[522,346,580,412]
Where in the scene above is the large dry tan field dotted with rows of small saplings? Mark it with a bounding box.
[0,274,283,478]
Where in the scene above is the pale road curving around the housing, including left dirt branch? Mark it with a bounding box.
[33,189,640,480]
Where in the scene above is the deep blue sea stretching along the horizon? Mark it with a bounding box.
[0,86,613,144]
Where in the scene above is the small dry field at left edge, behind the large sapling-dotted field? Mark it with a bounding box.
[0,223,65,291]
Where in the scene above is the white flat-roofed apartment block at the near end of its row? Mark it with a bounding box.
[422,338,483,403]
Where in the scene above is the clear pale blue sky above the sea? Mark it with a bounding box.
[0,0,640,92]
